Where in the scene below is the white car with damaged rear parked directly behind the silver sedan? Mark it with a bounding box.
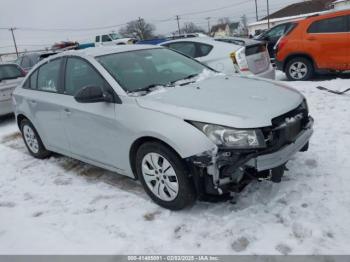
[160,37,275,79]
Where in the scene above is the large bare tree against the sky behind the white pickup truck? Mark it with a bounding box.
[119,18,156,40]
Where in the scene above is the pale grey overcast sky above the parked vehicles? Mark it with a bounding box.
[0,0,302,53]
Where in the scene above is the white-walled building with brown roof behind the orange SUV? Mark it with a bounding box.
[248,0,336,35]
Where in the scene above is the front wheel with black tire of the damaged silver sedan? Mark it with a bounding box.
[136,142,196,210]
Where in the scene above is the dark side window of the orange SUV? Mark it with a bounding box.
[307,16,348,34]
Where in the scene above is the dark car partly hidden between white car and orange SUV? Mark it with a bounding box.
[254,22,296,61]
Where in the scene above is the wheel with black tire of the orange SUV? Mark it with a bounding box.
[285,57,314,81]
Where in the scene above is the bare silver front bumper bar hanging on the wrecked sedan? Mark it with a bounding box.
[246,117,314,172]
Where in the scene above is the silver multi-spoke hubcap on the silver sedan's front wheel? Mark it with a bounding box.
[142,153,179,201]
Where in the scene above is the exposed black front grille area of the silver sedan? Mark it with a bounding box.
[263,102,309,150]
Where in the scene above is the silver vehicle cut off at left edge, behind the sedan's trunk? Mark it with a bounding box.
[0,63,26,116]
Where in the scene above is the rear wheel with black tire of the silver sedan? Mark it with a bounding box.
[20,119,51,159]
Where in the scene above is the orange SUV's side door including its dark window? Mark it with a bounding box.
[304,16,350,70]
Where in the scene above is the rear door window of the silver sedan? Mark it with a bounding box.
[37,59,62,93]
